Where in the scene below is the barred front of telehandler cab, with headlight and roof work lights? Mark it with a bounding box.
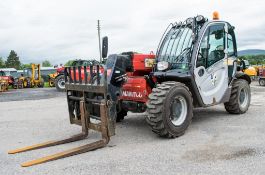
[156,15,208,72]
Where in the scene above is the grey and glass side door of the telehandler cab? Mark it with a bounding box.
[194,23,228,105]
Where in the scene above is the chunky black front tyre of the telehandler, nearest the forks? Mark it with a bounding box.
[146,81,193,138]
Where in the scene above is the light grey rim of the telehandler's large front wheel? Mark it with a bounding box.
[170,96,188,126]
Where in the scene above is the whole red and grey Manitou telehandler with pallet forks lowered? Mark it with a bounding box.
[9,13,251,166]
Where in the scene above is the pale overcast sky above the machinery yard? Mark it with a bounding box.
[0,0,265,64]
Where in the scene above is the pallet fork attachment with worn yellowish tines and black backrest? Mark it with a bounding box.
[8,65,115,167]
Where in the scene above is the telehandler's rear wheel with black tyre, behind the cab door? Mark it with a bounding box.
[224,79,251,114]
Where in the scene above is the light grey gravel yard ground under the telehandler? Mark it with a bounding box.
[0,83,265,175]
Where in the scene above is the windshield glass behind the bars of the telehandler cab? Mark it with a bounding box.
[157,25,192,67]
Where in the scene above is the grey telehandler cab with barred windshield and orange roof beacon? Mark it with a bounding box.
[153,12,237,106]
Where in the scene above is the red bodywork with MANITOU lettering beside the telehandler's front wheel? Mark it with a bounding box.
[120,54,155,103]
